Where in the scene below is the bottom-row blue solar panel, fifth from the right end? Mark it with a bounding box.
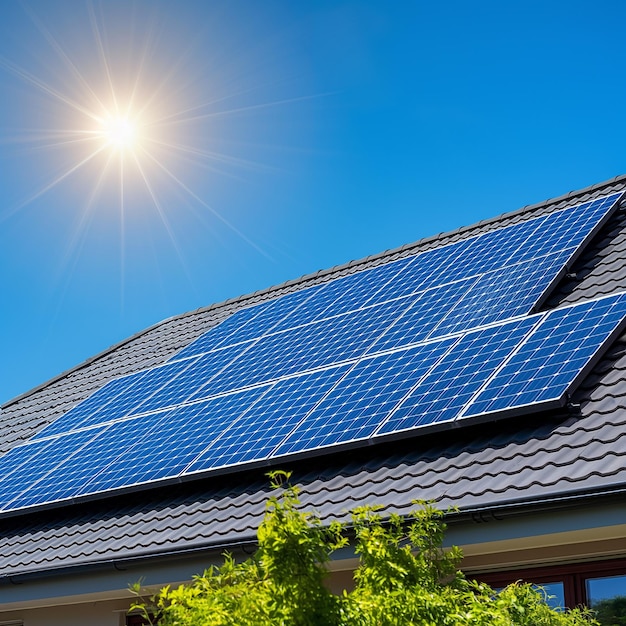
[76,386,269,494]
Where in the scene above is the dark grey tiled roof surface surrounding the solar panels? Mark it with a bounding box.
[0,172,626,577]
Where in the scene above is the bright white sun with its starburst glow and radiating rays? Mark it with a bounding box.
[0,0,299,266]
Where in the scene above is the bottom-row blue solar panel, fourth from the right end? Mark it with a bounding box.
[185,365,350,474]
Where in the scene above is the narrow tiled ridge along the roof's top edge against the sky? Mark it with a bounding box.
[0,174,626,411]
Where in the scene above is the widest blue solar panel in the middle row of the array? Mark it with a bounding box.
[190,298,410,400]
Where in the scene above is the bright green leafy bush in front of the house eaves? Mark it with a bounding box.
[130,472,597,626]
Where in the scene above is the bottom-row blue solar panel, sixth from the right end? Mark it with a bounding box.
[10,413,167,509]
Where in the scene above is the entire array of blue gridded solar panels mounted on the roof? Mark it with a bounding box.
[0,194,626,512]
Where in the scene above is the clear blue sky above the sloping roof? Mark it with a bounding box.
[0,0,626,403]
